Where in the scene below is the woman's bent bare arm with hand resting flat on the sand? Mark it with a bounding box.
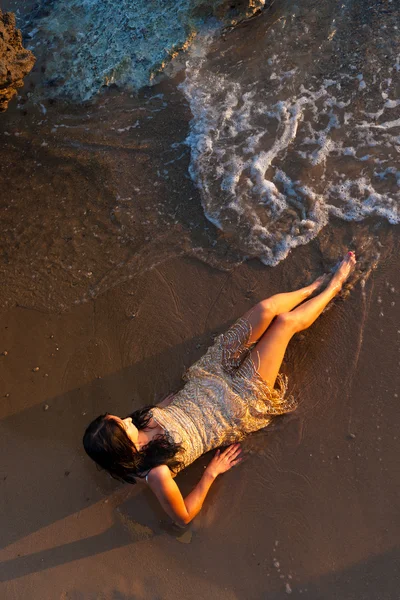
[148,444,242,527]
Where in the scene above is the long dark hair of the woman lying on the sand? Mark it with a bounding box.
[83,406,181,483]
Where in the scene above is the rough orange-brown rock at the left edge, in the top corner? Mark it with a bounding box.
[0,10,36,112]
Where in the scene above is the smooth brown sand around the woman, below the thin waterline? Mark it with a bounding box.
[0,233,400,600]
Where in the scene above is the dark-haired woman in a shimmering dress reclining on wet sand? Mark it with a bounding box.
[83,252,356,526]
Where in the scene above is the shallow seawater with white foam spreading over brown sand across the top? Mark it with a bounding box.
[0,0,400,310]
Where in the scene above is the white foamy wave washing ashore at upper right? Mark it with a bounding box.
[182,0,400,265]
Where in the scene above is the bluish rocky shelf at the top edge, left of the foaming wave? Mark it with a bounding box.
[21,0,269,102]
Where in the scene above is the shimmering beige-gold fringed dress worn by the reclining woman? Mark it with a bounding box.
[152,318,296,468]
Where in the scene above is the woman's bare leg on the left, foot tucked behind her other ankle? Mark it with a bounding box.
[243,275,327,345]
